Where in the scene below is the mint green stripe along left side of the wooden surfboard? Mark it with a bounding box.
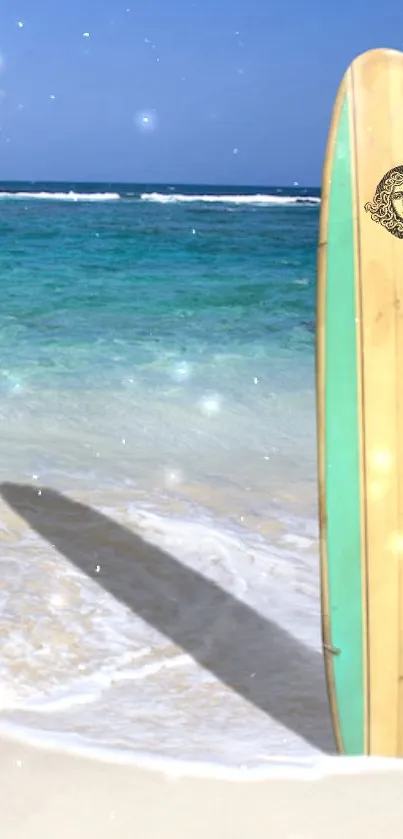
[325,97,365,755]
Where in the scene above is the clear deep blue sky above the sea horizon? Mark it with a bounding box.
[0,0,403,185]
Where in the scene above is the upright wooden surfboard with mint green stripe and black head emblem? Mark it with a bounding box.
[316,49,403,756]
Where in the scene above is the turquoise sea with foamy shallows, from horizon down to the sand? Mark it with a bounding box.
[0,184,333,764]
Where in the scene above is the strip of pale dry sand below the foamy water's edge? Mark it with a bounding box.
[0,738,403,839]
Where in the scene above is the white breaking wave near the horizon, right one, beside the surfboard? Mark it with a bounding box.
[140,192,320,207]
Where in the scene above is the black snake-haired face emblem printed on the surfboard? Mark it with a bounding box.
[364,166,403,239]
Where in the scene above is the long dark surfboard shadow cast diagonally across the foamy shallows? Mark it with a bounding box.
[0,483,335,752]
